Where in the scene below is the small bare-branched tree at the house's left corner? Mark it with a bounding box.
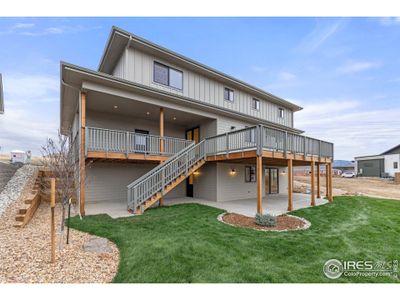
[42,133,85,247]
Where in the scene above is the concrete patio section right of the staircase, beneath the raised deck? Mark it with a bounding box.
[164,193,328,217]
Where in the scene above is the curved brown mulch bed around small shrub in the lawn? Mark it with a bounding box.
[222,213,308,231]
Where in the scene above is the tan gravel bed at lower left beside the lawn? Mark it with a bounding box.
[0,196,119,283]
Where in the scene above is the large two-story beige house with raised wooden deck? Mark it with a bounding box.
[60,27,333,214]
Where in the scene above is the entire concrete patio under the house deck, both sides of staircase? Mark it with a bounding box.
[86,193,328,218]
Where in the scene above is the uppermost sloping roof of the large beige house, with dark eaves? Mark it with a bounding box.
[98,26,302,111]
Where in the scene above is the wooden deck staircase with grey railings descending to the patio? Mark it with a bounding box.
[128,140,206,214]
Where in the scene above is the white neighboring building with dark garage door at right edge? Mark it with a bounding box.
[354,145,400,177]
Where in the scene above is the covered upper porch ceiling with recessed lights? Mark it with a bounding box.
[87,91,212,128]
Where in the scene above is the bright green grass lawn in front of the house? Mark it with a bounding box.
[71,197,400,282]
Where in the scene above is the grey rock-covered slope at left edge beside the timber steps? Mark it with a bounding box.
[0,165,36,217]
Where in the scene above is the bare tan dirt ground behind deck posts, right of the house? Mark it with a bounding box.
[294,176,400,200]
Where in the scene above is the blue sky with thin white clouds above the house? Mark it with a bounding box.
[0,17,400,160]
